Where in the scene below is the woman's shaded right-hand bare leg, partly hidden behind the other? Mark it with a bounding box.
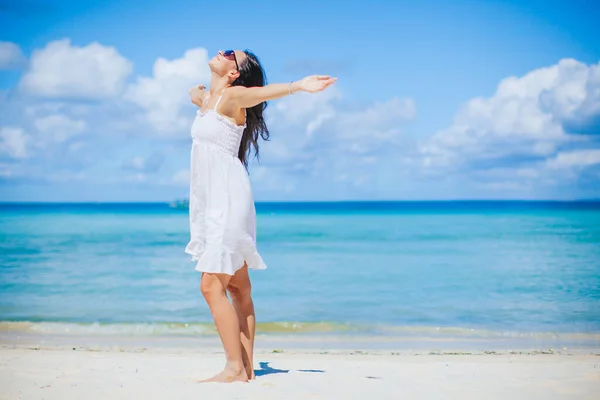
[227,263,256,379]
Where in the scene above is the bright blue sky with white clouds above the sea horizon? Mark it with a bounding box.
[0,0,600,201]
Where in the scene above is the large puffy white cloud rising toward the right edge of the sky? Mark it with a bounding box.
[421,59,600,167]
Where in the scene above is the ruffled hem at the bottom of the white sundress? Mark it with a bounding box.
[185,241,267,275]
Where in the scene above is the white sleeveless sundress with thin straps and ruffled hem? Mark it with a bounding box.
[185,95,267,275]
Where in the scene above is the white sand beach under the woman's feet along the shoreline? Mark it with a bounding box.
[0,340,600,400]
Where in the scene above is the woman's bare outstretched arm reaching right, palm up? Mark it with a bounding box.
[227,75,337,108]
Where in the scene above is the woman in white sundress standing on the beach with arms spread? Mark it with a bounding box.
[185,50,336,382]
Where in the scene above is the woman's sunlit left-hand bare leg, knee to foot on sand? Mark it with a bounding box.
[200,272,248,382]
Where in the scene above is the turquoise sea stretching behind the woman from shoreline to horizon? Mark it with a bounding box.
[0,201,600,346]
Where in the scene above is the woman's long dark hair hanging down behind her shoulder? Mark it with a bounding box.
[232,50,269,170]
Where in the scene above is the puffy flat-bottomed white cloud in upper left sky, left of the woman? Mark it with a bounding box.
[20,39,133,99]
